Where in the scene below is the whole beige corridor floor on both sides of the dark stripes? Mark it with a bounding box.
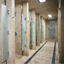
[16,42,59,64]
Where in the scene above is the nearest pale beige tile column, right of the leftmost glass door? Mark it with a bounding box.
[7,0,15,64]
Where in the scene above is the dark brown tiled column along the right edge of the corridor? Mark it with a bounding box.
[58,0,64,63]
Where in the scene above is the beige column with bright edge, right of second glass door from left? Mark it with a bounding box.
[23,1,30,55]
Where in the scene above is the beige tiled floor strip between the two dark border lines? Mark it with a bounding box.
[29,42,54,64]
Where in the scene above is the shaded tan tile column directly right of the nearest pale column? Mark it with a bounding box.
[15,0,21,55]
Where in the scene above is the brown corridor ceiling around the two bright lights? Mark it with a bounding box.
[21,0,58,19]
